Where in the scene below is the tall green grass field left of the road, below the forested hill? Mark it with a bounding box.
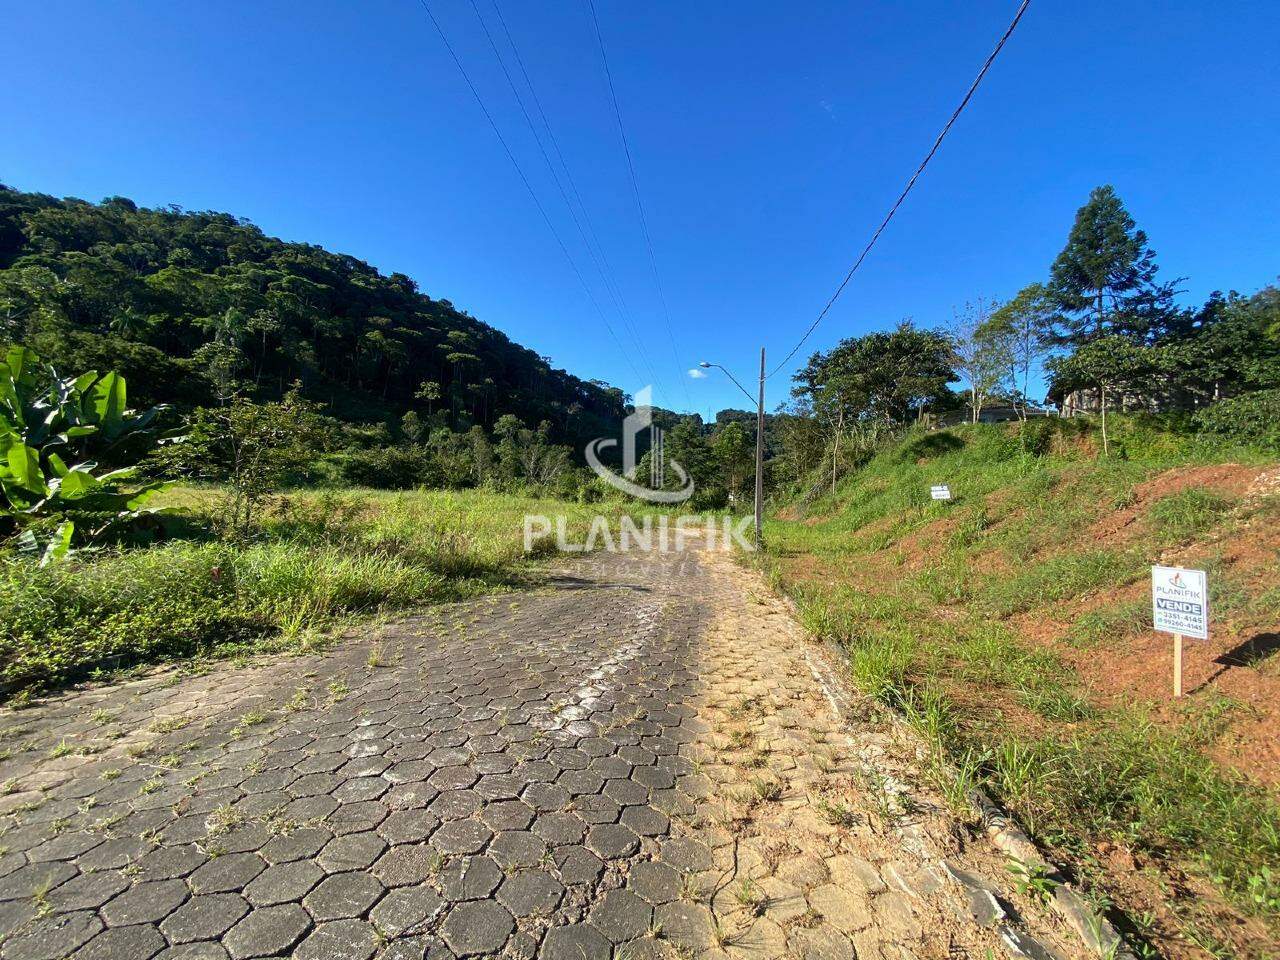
[0,488,637,692]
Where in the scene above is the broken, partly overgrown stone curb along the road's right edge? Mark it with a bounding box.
[772,588,1137,960]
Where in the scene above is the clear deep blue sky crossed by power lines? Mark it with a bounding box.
[0,0,1280,415]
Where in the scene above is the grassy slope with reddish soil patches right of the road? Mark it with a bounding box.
[763,419,1280,956]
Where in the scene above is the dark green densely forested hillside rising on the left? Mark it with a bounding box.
[0,186,623,448]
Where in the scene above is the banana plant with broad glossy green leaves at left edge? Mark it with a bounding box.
[0,347,165,563]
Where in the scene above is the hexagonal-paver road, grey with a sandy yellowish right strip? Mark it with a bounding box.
[0,545,1080,960]
